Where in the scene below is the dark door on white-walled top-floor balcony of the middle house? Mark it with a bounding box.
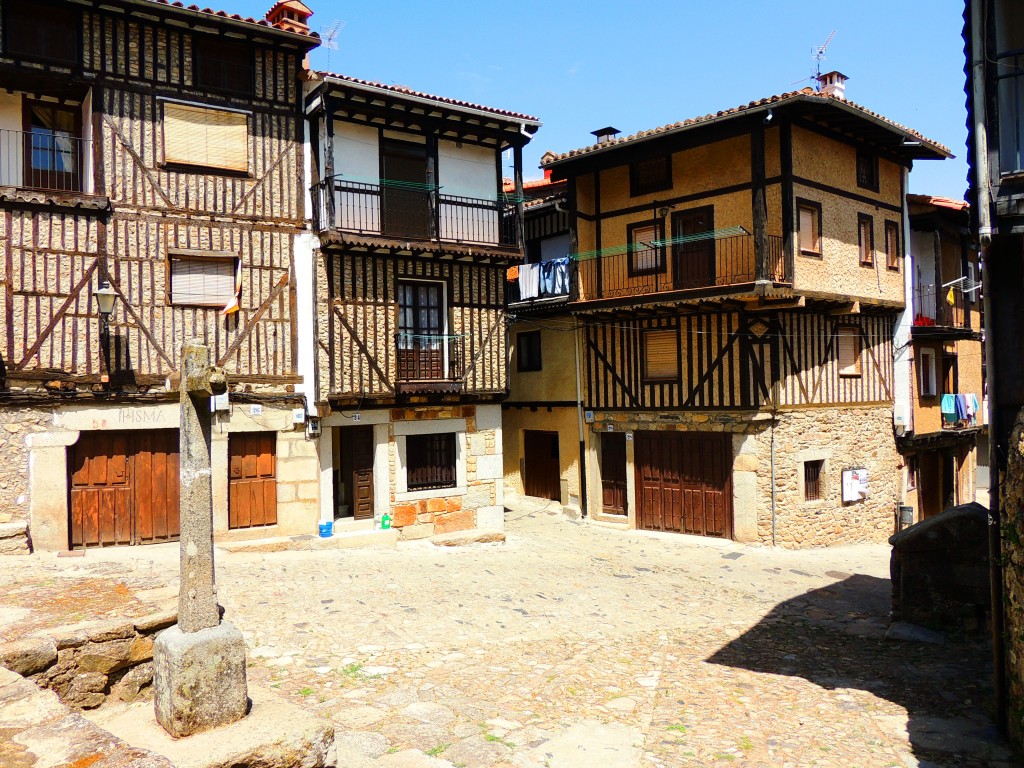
[381,139,431,240]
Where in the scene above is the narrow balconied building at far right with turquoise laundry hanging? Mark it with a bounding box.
[894,195,986,524]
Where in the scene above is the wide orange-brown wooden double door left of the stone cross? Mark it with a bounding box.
[68,429,180,549]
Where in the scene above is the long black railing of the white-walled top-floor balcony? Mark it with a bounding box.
[312,176,518,246]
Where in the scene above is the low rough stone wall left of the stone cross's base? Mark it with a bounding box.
[0,610,177,710]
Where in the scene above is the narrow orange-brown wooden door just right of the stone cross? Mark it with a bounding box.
[227,432,278,528]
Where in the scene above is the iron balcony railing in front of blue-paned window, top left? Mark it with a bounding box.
[0,128,92,193]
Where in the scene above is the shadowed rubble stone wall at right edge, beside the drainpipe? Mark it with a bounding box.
[999,411,1024,744]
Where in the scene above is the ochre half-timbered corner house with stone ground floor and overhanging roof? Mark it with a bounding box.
[506,73,949,547]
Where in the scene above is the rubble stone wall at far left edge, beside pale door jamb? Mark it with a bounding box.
[0,407,52,555]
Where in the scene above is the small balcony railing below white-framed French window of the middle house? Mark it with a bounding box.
[395,333,465,393]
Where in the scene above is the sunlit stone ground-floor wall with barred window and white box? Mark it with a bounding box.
[757,406,900,548]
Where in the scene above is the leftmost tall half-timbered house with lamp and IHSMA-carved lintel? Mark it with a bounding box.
[0,0,317,550]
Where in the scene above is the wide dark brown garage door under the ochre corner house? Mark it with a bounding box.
[636,432,732,538]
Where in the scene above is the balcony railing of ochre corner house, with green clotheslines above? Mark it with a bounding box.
[575,234,786,301]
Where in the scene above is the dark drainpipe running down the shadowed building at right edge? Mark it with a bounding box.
[970,0,1009,734]
